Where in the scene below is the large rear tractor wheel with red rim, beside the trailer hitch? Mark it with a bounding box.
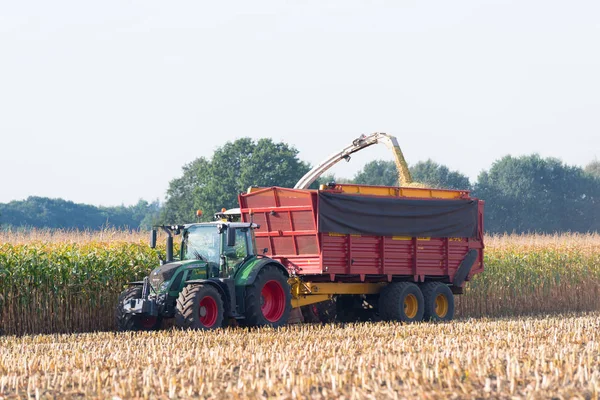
[244,265,292,328]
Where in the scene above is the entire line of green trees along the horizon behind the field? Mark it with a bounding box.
[0,138,600,233]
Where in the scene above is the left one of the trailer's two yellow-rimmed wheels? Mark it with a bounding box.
[379,282,425,322]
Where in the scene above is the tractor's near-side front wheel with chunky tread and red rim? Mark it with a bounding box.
[175,284,225,330]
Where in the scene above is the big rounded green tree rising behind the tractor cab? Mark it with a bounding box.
[161,138,309,223]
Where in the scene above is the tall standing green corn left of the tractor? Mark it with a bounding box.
[0,242,157,334]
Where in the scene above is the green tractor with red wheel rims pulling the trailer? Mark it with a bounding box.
[116,221,291,331]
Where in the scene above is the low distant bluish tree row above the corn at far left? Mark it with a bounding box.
[0,196,159,229]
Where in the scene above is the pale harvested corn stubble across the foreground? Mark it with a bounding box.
[0,313,600,399]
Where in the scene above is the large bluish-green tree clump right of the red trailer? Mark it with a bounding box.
[475,154,600,233]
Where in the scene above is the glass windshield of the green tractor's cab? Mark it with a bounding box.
[182,225,221,264]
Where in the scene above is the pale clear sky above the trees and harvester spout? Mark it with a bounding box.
[0,0,600,205]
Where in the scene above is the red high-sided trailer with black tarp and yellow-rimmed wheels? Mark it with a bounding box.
[239,185,484,321]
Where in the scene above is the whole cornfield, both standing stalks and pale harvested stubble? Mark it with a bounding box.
[0,231,600,399]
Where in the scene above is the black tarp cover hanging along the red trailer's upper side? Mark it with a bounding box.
[319,192,477,238]
